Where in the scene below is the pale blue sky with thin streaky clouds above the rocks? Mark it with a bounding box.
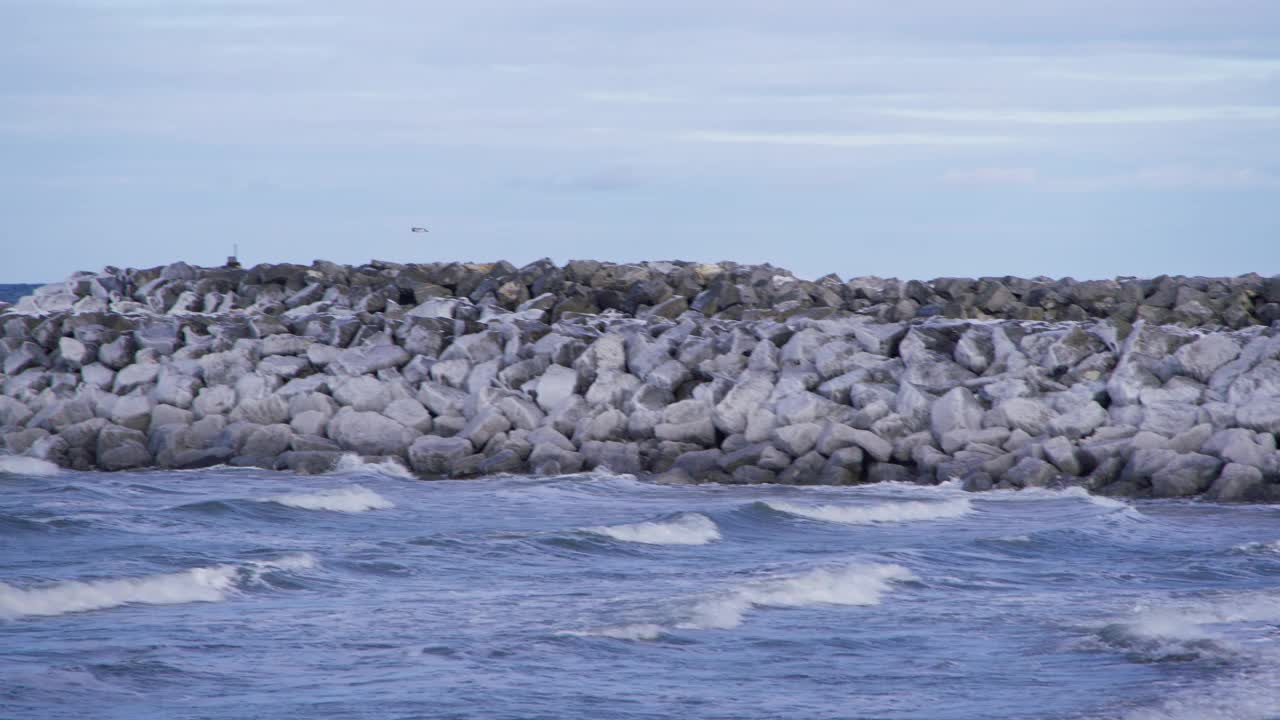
[0,0,1280,282]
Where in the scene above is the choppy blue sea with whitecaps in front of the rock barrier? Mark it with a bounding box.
[0,457,1280,720]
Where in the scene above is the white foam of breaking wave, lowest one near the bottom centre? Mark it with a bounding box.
[677,565,915,629]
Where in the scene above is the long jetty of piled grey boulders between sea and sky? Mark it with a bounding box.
[0,260,1280,501]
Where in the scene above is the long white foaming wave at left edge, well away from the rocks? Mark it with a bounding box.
[0,553,316,618]
